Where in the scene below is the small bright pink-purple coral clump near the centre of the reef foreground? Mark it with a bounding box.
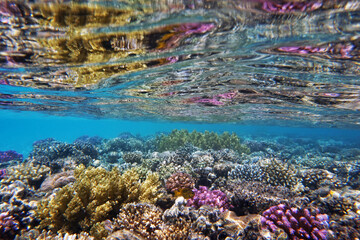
[187,186,231,212]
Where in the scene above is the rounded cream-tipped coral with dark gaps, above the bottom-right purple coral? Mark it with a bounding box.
[261,159,299,189]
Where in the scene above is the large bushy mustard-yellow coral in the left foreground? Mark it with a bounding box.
[37,166,160,237]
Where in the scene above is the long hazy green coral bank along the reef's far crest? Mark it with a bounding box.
[156,129,250,153]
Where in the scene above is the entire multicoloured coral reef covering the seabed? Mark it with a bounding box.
[0,130,360,240]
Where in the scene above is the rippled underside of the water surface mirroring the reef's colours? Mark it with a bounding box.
[0,0,360,127]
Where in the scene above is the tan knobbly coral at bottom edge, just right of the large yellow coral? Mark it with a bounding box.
[106,203,190,240]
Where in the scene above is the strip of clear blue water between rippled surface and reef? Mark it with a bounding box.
[0,111,360,156]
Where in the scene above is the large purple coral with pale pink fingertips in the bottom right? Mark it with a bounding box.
[261,204,329,240]
